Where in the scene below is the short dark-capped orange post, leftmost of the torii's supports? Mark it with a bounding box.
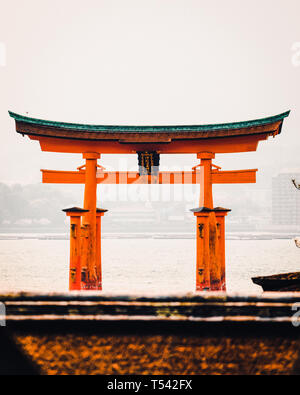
[63,207,87,291]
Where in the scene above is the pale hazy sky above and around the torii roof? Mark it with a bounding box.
[0,0,300,184]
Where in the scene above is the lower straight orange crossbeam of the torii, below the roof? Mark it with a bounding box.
[41,169,257,184]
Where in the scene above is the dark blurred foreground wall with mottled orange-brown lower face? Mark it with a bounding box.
[0,293,300,375]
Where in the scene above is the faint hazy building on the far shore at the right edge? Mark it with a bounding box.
[272,169,300,226]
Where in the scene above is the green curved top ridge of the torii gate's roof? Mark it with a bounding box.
[9,111,290,133]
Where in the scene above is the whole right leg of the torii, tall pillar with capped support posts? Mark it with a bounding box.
[191,152,230,291]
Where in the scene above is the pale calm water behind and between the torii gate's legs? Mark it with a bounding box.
[0,239,300,294]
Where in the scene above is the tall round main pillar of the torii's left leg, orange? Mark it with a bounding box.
[82,152,101,290]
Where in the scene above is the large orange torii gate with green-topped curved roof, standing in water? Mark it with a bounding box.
[10,112,289,291]
